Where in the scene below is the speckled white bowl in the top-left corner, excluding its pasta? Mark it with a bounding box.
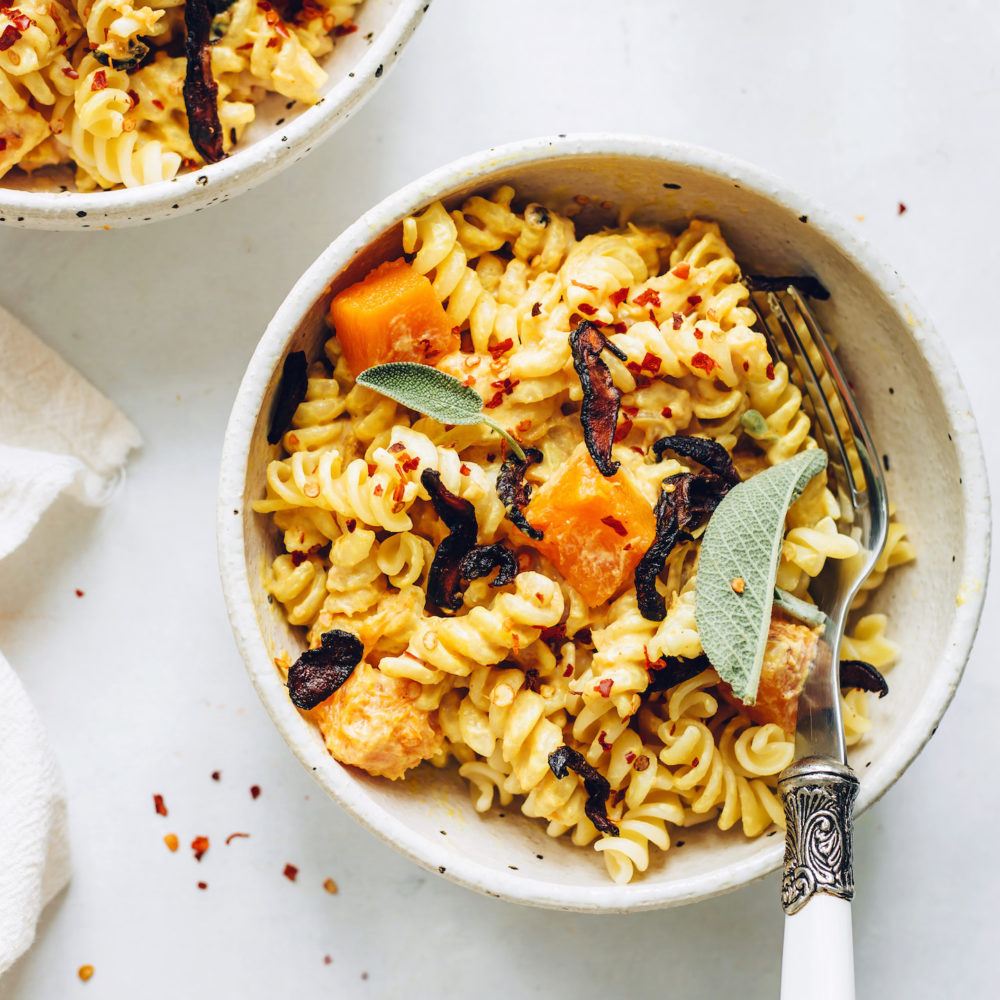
[0,0,430,229]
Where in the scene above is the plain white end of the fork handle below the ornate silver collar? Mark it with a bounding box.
[781,892,854,1000]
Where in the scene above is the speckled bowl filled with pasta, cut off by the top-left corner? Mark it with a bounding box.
[0,0,429,229]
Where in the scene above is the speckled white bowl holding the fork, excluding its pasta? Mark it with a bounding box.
[218,135,990,912]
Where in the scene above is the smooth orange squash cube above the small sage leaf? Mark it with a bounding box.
[330,258,461,376]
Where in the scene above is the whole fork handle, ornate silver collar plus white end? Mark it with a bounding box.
[778,757,858,1000]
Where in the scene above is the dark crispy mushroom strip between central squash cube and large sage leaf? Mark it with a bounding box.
[635,472,730,622]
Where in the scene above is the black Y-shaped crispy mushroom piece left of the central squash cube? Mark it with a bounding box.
[420,469,520,611]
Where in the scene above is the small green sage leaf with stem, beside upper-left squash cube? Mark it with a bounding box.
[356,361,525,462]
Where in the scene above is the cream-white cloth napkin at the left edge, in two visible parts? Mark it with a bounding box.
[0,309,141,975]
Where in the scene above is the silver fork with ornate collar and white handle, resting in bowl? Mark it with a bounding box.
[750,285,889,1000]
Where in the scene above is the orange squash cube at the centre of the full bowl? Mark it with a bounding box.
[526,445,656,607]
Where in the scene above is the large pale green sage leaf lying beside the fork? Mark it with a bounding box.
[694,448,826,705]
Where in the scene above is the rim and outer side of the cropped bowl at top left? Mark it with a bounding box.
[0,0,431,230]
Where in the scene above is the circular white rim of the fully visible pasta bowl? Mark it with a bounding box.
[218,133,991,913]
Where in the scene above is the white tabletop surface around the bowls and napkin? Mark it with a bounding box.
[0,0,1000,1000]
